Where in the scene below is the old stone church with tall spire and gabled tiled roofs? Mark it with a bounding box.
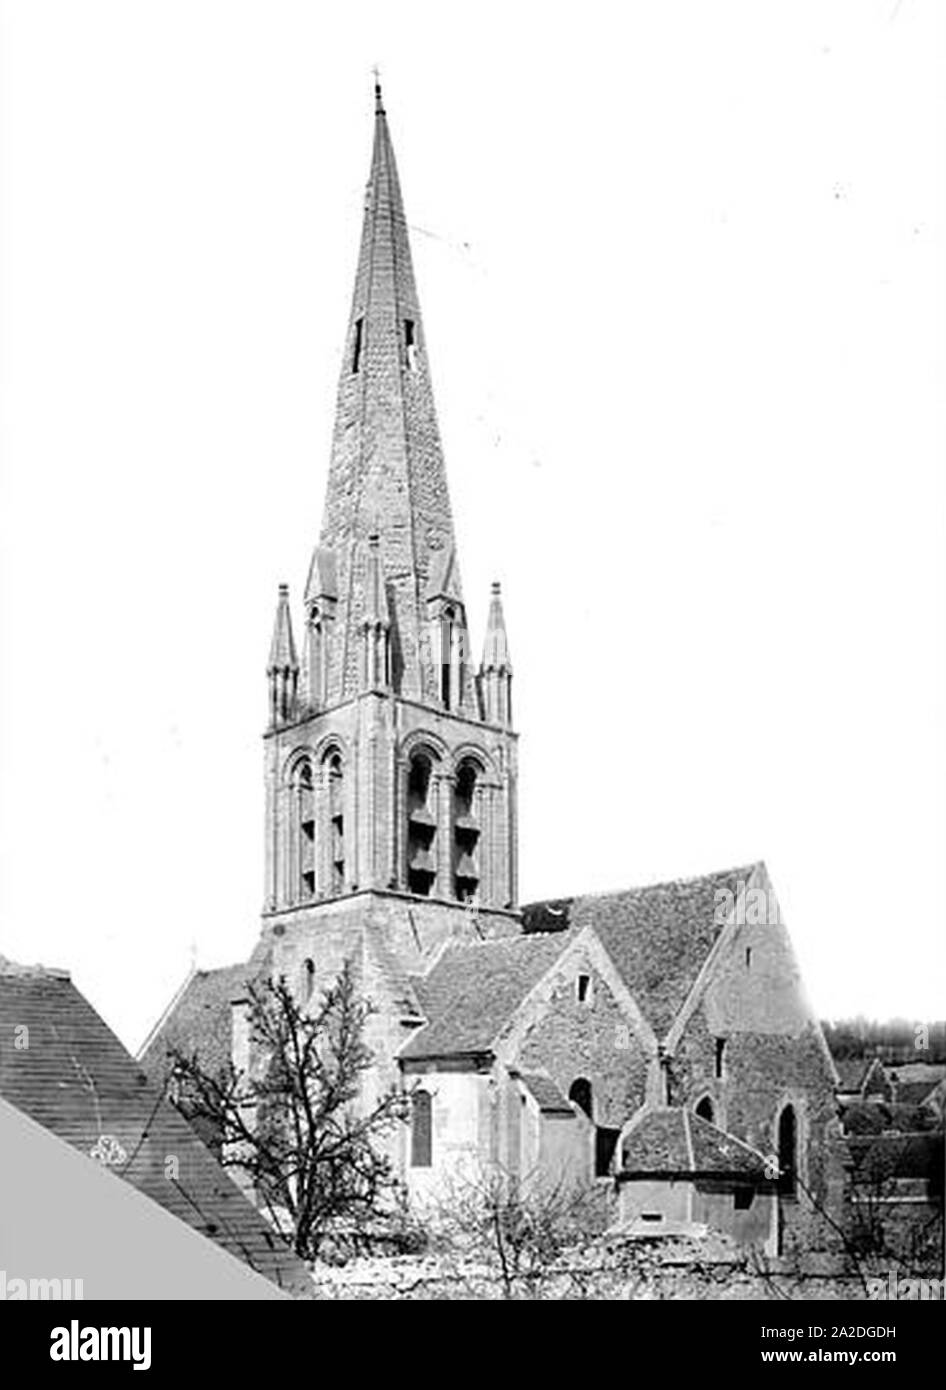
[139,86,839,1251]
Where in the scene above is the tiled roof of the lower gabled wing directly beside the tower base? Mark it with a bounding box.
[400,934,571,1058]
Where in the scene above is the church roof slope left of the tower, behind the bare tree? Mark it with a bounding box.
[138,965,254,1084]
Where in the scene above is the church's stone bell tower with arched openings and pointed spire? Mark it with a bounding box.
[264,86,520,1084]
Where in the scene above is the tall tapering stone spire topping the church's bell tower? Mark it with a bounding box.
[306,85,466,713]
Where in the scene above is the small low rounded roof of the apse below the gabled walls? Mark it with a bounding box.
[617,1105,765,1180]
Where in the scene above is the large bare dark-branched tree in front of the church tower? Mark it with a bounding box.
[171,960,407,1259]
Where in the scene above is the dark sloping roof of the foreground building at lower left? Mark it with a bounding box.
[0,972,308,1289]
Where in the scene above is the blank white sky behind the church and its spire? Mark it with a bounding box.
[0,0,946,1045]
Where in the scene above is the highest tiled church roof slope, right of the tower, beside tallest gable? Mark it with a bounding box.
[522,865,757,1034]
